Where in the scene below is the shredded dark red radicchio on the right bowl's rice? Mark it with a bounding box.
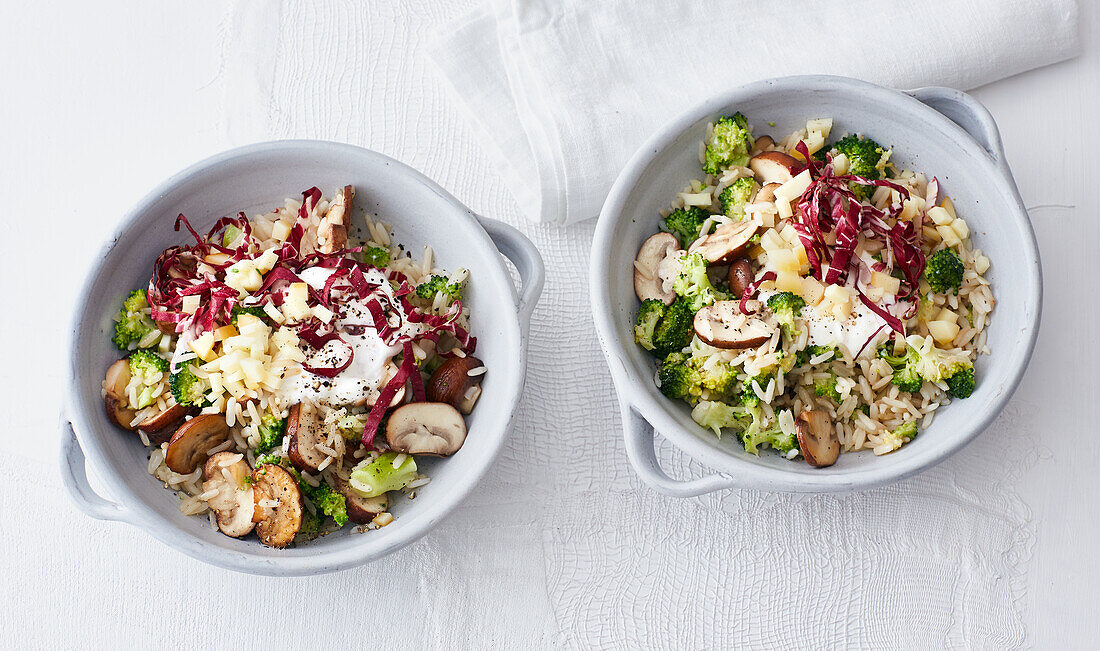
[792,142,938,332]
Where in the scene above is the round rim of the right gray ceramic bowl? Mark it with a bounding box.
[589,75,1043,494]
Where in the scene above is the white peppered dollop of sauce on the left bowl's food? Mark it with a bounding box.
[279,267,407,407]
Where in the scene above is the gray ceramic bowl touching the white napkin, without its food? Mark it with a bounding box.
[591,76,1042,496]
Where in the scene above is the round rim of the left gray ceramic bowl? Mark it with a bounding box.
[62,139,527,576]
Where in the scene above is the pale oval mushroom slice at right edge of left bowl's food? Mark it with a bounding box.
[386,402,466,456]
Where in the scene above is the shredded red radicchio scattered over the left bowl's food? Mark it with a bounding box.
[147,182,477,446]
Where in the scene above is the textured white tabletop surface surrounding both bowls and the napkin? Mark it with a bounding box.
[0,0,1100,649]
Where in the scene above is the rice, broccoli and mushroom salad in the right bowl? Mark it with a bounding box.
[634,113,996,467]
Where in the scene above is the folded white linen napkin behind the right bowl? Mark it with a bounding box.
[429,0,1079,223]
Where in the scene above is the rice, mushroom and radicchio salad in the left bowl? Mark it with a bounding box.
[103,186,486,548]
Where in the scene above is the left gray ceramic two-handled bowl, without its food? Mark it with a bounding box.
[62,141,543,575]
